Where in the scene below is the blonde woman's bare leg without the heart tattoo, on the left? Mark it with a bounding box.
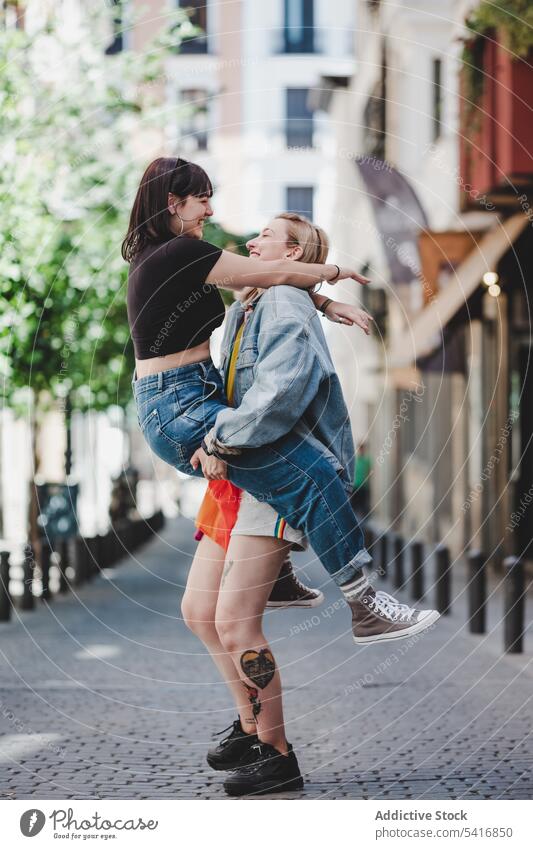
[181,536,256,734]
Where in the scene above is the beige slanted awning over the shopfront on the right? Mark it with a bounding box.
[390,212,528,368]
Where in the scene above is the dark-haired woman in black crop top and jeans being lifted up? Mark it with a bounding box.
[127,159,434,642]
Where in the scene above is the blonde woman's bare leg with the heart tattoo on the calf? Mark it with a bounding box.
[216,536,290,754]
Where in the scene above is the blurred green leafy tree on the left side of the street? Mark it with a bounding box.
[0,3,242,416]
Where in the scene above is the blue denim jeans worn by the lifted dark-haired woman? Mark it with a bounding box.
[132,360,371,584]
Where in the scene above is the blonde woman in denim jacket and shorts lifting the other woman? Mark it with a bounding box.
[182,213,438,795]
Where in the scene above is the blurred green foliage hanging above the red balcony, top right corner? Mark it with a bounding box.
[462,0,533,121]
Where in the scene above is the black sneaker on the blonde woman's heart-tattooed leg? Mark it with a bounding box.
[224,742,304,796]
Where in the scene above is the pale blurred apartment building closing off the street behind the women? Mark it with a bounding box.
[130,0,355,233]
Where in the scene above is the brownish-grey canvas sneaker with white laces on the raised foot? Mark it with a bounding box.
[346,587,440,643]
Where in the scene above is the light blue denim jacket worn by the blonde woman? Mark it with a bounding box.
[213,286,355,492]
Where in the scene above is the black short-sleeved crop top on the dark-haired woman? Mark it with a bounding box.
[127,236,224,360]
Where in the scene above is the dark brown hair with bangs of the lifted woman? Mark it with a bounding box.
[122,157,213,262]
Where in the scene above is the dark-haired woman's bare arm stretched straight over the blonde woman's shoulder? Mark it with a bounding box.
[206,251,369,289]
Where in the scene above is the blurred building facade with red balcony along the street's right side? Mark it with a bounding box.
[322,0,533,564]
